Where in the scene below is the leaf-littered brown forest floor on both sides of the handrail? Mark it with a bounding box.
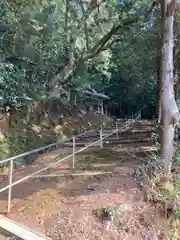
[0,121,180,240]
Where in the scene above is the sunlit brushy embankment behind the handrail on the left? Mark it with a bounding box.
[0,99,108,167]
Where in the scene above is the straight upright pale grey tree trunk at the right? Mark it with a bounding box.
[160,0,179,174]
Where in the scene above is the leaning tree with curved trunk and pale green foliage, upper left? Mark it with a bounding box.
[0,0,144,108]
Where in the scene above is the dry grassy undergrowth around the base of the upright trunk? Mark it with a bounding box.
[142,148,180,240]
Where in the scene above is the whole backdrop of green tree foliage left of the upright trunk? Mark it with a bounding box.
[0,0,179,117]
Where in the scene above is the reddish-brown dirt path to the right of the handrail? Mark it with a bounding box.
[0,145,167,240]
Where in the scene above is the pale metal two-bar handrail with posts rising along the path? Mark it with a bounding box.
[0,109,140,212]
